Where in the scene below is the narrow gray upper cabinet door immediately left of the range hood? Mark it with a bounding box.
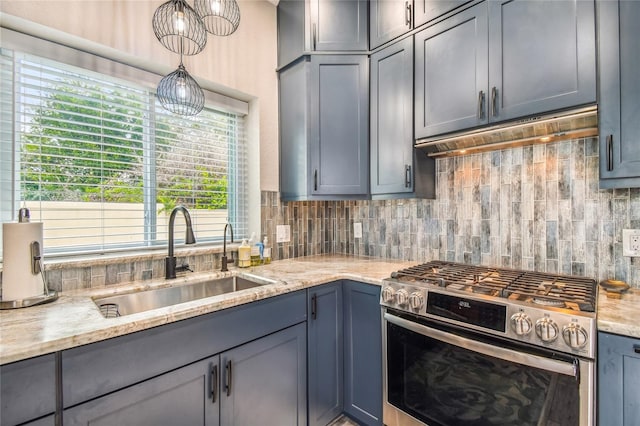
[370,37,413,195]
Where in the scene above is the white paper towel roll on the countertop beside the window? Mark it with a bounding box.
[2,222,44,301]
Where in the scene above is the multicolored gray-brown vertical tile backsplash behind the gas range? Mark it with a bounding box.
[262,138,640,287]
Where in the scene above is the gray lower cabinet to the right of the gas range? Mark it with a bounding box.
[597,332,640,426]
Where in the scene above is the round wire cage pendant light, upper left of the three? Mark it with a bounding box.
[152,0,207,55]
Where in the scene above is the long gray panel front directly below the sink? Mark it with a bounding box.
[62,291,306,408]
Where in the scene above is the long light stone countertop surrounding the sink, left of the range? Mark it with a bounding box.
[0,255,416,365]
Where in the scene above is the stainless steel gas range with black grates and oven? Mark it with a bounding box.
[381,261,597,426]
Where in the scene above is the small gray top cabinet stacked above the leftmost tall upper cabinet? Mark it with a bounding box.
[278,0,368,67]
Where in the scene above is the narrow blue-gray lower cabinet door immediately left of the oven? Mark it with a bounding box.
[343,281,382,425]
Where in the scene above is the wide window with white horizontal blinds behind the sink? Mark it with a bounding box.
[0,49,248,254]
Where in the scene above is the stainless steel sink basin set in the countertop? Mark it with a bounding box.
[93,276,274,318]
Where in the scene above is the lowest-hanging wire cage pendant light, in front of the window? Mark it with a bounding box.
[157,61,204,115]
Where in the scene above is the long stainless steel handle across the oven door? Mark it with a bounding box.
[384,313,579,379]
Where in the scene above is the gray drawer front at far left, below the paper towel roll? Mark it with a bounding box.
[0,354,56,426]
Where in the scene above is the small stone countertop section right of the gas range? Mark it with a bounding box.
[598,288,640,338]
